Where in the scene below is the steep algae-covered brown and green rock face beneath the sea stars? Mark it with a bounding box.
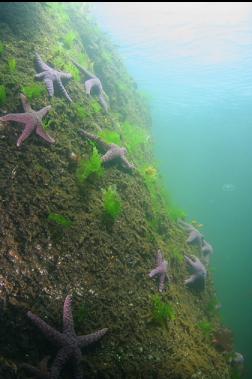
[0,3,229,379]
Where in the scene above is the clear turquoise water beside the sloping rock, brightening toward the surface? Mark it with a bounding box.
[93,3,252,379]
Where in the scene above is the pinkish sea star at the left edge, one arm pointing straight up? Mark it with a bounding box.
[0,93,55,146]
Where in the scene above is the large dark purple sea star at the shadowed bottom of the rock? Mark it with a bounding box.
[27,295,108,379]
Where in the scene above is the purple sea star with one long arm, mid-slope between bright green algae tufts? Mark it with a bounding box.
[80,129,135,170]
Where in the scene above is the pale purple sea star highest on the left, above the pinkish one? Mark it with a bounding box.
[35,53,72,102]
